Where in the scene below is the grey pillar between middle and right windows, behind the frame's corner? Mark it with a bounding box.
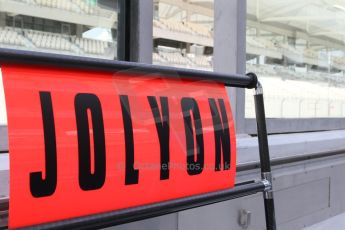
[213,0,246,133]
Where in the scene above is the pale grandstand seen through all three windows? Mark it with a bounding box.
[0,0,345,117]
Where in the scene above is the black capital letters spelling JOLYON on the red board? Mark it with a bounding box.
[30,92,230,198]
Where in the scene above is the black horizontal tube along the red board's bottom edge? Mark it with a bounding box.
[0,181,270,229]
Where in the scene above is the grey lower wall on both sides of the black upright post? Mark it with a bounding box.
[179,155,345,230]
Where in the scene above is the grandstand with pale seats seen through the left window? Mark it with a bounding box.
[0,0,117,59]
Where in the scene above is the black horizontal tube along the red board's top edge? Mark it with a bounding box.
[0,48,257,89]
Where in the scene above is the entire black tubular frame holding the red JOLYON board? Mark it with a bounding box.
[0,49,276,230]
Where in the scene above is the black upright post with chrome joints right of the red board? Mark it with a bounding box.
[247,73,276,230]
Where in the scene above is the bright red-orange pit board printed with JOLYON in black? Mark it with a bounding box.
[1,64,236,228]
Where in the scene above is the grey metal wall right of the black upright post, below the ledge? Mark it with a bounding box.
[274,155,345,229]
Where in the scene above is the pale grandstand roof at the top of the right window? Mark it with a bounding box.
[247,0,345,48]
